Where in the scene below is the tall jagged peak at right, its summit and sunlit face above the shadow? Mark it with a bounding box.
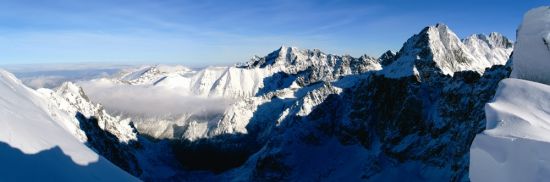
[381,24,512,79]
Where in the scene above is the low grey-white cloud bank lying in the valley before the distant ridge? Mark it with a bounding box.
[79,79,232,118]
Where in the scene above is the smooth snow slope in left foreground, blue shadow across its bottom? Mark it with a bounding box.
[0,70,137,181]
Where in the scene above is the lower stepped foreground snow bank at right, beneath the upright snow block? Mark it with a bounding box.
[470,79,550,181]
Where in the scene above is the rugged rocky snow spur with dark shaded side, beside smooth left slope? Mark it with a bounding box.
[38,82,142,176]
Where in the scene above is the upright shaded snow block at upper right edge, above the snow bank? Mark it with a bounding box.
[512,6,550,84]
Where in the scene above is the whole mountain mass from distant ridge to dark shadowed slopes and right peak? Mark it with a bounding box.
[72,24,512,181]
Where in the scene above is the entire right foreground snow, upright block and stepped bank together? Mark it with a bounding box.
[470,6,550,181]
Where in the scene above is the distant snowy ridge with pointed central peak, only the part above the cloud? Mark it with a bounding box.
[102,46,381,98]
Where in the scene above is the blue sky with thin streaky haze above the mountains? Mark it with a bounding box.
[0,0,548,66]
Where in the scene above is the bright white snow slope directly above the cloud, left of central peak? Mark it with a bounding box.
[110,65,273,98]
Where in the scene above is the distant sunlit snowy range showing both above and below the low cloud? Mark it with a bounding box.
[78,46,381,140]
